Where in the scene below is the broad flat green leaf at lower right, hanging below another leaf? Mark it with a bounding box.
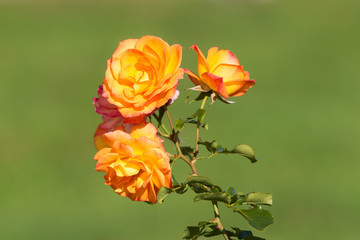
[233,206,274,231]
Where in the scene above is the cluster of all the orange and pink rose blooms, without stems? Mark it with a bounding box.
[93,36,255,203]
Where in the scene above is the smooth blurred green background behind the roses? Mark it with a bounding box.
[0,0,360,240]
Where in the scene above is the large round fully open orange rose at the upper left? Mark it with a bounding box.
[103,36,184,122]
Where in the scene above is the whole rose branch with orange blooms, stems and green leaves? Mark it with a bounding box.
[93,36,273,240]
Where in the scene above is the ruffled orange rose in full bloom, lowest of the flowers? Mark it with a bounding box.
[94,122,171,203]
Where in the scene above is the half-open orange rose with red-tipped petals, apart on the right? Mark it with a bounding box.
[185,45,255,99]
